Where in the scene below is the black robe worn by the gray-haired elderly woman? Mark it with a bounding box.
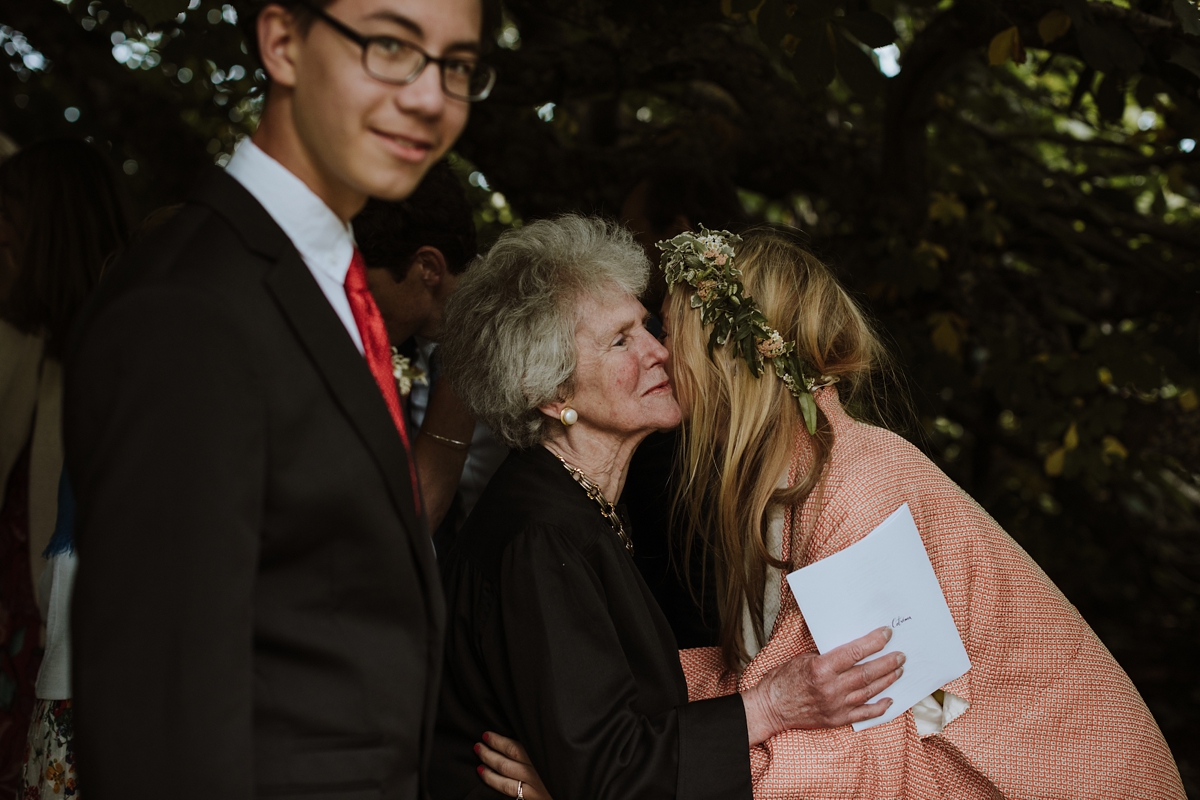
[430,447,751,800]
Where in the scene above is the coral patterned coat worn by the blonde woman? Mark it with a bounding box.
[680,389,1184,800]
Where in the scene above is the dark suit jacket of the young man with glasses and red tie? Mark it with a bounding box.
[65,173,445,800]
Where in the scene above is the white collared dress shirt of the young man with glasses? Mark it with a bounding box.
[226,139,364,353]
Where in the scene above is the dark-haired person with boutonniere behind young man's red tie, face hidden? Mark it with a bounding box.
[354,162,509,553]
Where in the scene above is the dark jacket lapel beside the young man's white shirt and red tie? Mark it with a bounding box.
[193,172,437,556]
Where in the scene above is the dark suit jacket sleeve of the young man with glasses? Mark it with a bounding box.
[64,288,265,800]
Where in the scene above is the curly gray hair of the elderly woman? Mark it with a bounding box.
[439,213,650,449]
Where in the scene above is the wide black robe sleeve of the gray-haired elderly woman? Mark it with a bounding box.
[496,529,750,800]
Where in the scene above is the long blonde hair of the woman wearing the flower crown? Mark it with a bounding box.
[667,227,887,670]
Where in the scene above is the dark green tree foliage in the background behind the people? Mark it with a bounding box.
[0,0,1200,793]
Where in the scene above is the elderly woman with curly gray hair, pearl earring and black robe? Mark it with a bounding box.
[430,216,902,800]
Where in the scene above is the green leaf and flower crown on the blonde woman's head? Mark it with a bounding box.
[655,225,838,433]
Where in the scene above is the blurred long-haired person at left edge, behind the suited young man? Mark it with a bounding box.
[0,139,130,796]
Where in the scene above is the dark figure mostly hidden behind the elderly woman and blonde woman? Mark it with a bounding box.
[620,164,746,648]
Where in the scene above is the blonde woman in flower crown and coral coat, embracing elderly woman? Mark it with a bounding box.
[482,228,1184,800]
